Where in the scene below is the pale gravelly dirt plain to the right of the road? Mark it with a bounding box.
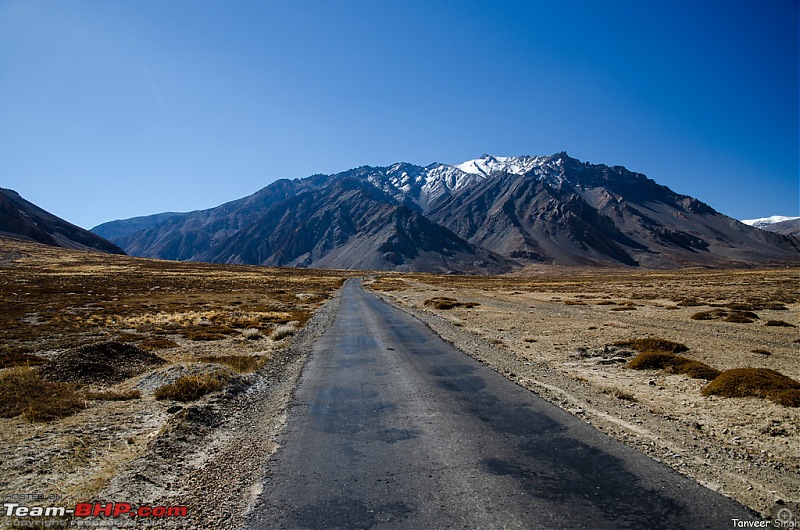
[373,268,800,515]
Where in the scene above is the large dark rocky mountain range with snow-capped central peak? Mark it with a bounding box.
[92,153,800,273]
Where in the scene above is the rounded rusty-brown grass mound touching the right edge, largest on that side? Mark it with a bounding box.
[703,368,800,407]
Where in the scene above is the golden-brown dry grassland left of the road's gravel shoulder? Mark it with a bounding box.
[0,238,345,506]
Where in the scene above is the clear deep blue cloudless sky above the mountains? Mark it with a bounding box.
[0,0,800,228]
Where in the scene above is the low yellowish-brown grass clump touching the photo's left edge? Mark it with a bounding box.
[0,366,85,421]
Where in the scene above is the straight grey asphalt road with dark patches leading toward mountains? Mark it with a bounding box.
[248,280,753,529]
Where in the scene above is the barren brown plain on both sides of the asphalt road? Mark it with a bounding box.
[0,239,800,528]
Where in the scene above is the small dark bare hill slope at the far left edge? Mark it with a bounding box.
[0,188,125,254]
